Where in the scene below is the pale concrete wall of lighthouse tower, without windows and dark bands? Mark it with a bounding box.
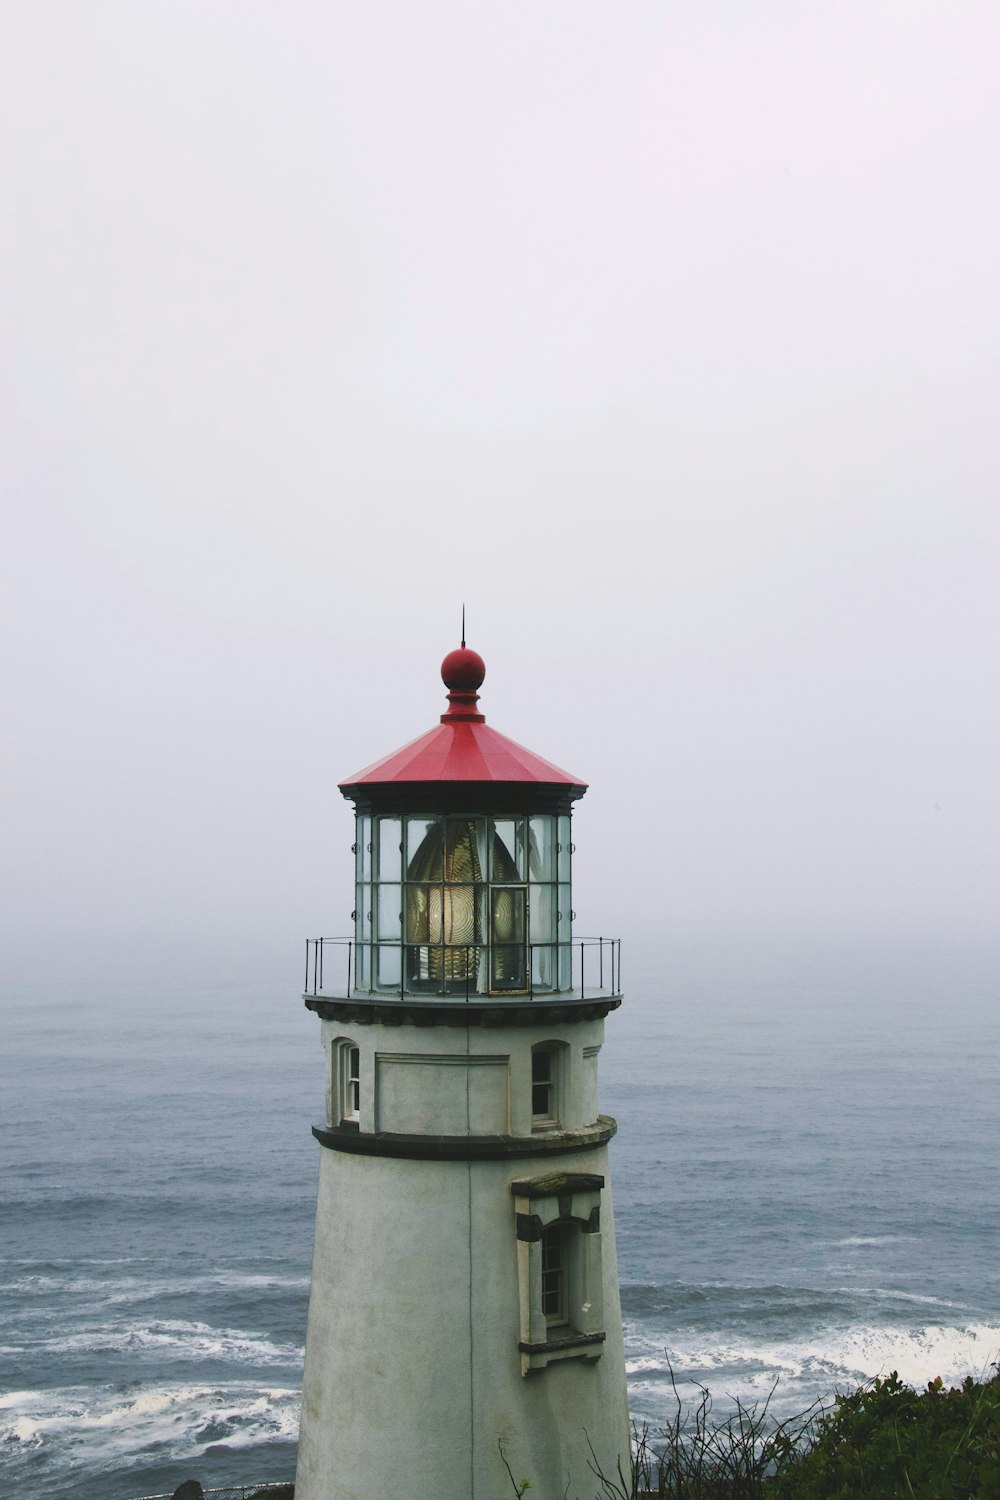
[295,1022,628,1500]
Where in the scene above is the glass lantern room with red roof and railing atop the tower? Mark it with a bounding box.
[306,642,619,1004]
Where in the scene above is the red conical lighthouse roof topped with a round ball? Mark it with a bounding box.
[340,642,586,798]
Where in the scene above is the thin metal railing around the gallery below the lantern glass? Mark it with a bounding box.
[304,938,622,1005]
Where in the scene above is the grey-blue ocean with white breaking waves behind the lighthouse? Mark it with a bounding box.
[0,939,1000,1500]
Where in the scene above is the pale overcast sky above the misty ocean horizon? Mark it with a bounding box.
[0,0,1000,989]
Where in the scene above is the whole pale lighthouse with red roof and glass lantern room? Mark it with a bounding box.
[295,642,630,1500]
